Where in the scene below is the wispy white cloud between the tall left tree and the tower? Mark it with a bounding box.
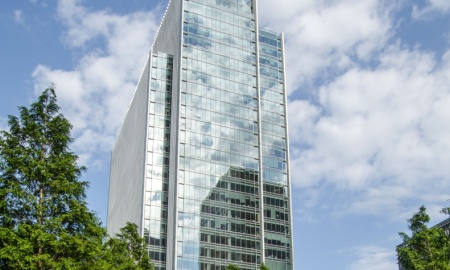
[33,0,159,167]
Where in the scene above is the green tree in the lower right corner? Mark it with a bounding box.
[397,206,450,270]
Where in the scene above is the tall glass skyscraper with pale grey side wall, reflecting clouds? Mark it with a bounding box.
[107,0,293,270]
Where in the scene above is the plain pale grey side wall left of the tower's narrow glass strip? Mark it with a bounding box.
[107,59,150,236]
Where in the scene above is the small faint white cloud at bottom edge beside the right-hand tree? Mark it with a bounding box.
[348,246,398,270]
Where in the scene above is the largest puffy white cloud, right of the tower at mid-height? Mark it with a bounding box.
[290,45,450,215]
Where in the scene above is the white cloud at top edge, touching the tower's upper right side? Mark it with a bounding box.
[259,0,394,93]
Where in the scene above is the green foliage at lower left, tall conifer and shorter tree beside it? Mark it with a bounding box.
[0,87,151,269]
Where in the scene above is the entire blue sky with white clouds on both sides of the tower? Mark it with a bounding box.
[0,0,450,270]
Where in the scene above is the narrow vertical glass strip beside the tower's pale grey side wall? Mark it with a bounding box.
[144,53,173,264]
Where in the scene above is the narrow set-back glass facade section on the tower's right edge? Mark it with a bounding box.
[259,29,292,269]
